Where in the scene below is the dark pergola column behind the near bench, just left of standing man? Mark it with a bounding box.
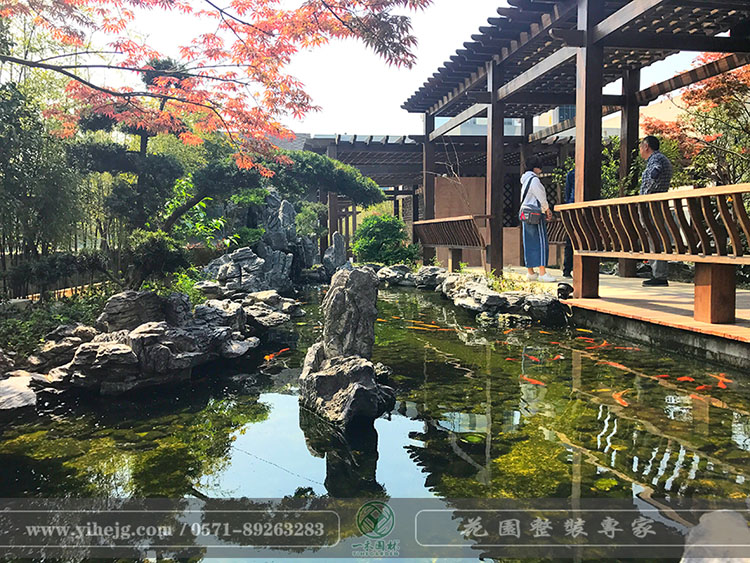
[617,69,641,278]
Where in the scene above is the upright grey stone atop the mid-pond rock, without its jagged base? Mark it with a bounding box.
[323,268,378,358]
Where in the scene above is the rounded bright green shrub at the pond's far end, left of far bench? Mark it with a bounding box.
[353,215,420,265]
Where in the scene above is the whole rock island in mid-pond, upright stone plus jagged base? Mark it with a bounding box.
[300,268,396,427]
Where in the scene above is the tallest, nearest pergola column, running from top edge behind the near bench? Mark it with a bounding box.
[573,0,604,298]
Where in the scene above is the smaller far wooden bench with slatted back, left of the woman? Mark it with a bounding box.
[414,215,492,272]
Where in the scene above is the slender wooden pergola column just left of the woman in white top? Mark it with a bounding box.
[485,62,505,275]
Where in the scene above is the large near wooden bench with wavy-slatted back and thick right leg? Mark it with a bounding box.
[557,184,750,323]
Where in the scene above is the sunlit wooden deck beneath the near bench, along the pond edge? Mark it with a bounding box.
[506,267,750,344]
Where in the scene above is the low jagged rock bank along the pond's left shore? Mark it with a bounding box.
[0,291,304,412]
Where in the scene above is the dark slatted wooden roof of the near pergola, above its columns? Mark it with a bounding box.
[402,0,750,117]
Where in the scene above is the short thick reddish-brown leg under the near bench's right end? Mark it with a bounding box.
[693,262,737,324]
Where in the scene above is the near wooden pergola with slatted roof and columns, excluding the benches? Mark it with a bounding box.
[403,0,750,318]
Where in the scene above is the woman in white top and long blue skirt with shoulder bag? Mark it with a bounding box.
[521,157,556,282]
